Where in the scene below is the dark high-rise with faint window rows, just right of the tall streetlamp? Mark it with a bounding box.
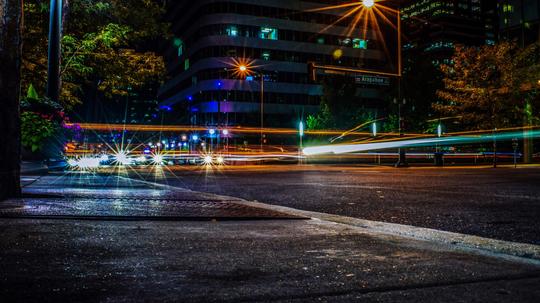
[401,0,498,65]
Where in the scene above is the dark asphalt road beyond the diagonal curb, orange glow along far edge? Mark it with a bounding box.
[130,165,540,244]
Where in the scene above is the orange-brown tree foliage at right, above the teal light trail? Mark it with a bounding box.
[434,42,540,129]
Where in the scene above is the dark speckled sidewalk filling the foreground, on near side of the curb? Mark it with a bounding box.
[0,174,540,302]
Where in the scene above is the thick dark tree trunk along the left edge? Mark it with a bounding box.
[0,0,23,201]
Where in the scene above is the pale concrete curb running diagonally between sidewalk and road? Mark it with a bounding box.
[123,177,540,266]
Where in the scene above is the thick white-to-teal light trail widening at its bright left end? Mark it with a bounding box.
[303,130,540,156]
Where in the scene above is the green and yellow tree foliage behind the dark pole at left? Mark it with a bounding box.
[23,0,169,108]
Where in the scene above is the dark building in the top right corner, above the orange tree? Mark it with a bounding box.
[498,0,540,46]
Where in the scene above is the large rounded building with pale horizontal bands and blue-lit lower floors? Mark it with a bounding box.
[159,0,395,127]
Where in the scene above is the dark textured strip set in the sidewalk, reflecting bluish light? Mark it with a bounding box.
[0,197,306,220]
